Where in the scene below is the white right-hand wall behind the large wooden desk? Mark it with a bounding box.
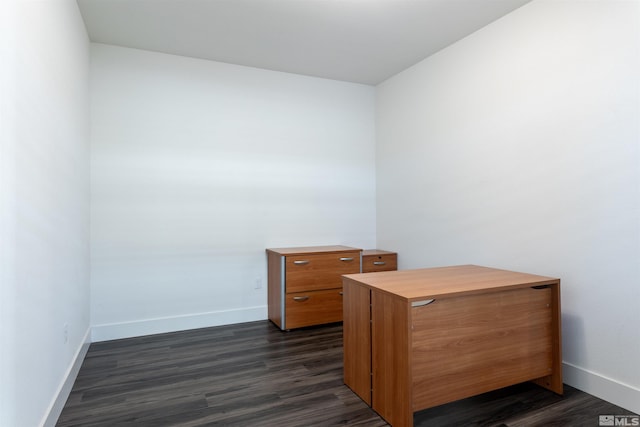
[376,0,640,413]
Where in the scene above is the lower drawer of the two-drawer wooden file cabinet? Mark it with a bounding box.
[285,287,342,329]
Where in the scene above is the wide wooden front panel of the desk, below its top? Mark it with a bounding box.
[412,288,553,411]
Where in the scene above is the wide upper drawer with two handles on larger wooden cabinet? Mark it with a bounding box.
[285,251,360,294]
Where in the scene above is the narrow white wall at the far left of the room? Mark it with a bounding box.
[0,0,89,427]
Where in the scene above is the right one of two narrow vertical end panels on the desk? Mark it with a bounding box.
[371,290,413,427]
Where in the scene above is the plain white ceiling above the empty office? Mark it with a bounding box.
[78,0,531,85]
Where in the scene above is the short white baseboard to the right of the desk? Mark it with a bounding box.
[562,362,640,415]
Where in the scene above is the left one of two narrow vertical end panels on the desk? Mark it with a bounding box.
[342,279,371,406]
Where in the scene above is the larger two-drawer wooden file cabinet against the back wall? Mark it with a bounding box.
[267,246,361,330]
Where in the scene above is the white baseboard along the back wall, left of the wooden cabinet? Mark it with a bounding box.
[91,306,267,342]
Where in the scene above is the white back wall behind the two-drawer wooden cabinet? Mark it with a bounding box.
[91,44,375,340]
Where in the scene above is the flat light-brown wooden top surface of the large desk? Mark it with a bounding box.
[342,265,560,301]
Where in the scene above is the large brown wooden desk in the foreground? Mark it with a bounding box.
[343,265,562,426]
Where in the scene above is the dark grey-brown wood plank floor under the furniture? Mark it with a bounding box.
[57,321,631,427]
